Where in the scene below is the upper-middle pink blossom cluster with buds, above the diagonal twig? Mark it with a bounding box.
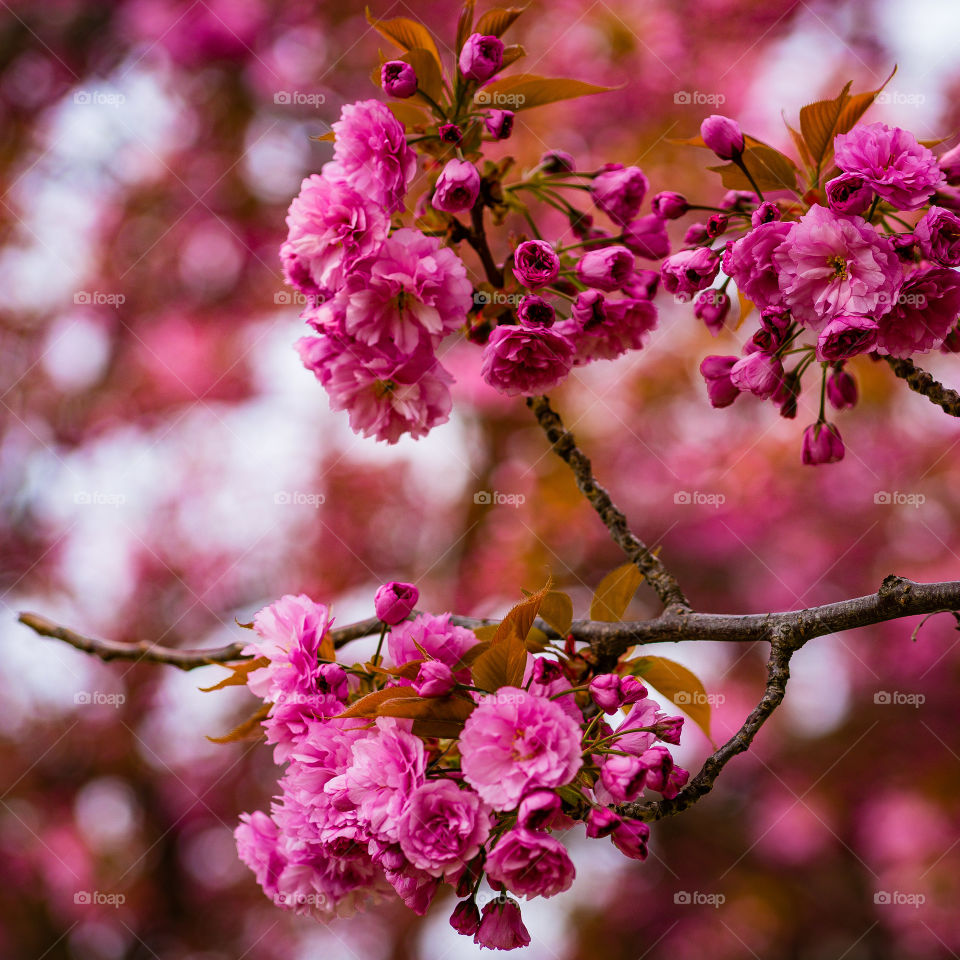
[281,10,669,443]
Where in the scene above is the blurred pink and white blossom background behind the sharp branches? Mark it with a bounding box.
[0,0,960,960]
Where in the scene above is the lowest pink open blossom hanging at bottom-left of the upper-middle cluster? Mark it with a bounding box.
[296,336,453,443]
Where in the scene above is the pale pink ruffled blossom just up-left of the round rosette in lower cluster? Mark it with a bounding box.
[344,717,426,843]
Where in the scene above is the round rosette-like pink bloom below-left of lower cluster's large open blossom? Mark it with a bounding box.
[398,780,490,877]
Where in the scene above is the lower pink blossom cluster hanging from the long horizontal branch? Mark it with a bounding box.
[236,583,688,950]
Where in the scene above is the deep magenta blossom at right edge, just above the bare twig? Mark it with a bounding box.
[877,267,960,357]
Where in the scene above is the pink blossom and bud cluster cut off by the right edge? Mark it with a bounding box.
[668,116,960,464]
